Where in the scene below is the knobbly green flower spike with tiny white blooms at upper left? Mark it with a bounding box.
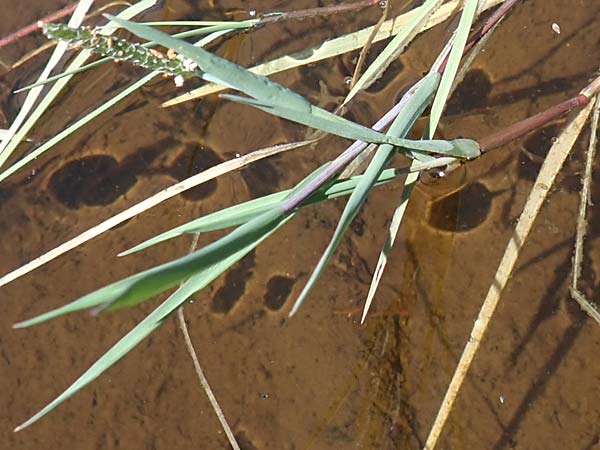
[43,23,196,78]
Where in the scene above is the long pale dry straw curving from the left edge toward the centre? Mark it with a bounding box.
[0,140,314,286]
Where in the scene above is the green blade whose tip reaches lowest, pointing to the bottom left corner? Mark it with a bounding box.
[15,216,291,431]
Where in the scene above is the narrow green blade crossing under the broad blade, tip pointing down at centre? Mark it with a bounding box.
[290,73,440,316]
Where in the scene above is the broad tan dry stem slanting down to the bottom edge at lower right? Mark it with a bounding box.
[424,96,595,450]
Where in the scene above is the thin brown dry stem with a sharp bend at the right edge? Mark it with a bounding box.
[570,96,600,324]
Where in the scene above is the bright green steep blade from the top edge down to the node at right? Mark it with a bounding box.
[428,0,478,138]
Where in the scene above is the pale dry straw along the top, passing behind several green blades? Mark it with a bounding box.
[162,0,505,107]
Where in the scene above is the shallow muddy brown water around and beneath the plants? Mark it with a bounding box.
[0,0,600,450]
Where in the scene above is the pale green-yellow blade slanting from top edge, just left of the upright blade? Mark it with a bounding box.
[344,0,442,104]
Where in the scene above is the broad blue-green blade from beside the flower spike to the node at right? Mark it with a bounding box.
[112,17,479,158]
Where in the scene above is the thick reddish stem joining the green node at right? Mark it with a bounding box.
[479,94,590,152]
